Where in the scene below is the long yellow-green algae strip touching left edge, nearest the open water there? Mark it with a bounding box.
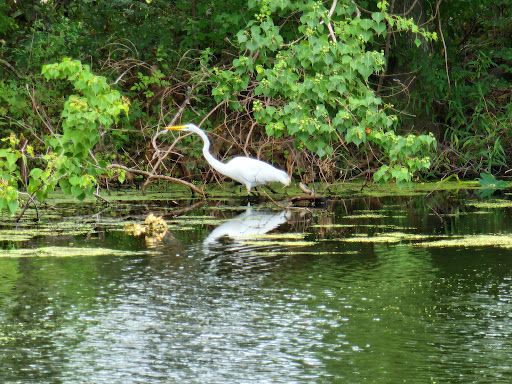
[0,247,148,257]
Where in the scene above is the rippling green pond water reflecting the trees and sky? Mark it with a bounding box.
[0,194,512,383]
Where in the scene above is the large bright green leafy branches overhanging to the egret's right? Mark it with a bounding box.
[212,0,435,185]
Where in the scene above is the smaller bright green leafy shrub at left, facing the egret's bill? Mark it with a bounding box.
[0,59,129,213]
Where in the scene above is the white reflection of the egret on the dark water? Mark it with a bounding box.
[203,207,289,249]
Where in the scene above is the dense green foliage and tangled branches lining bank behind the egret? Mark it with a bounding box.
[0,0,512,213]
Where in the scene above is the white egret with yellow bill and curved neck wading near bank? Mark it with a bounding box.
[165,124,291,194]
